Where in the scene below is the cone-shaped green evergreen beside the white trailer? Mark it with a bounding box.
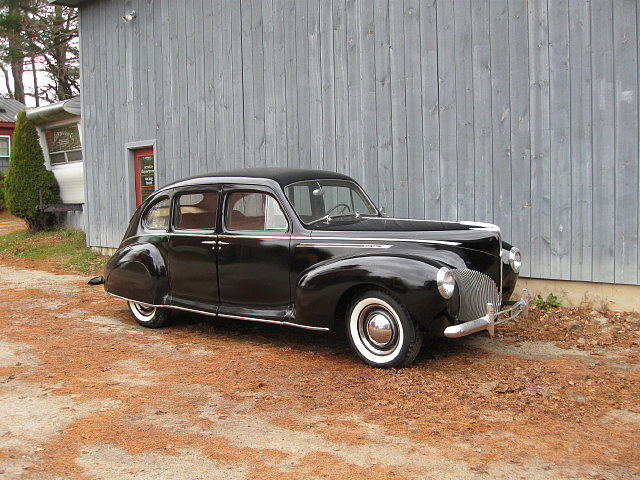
[5,112,60,231]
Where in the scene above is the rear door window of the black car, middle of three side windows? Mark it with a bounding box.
[174,192,220,230]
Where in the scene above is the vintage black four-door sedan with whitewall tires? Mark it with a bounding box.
[90,169,529,368]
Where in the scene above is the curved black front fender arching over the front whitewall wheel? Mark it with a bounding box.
[295,255,448,328]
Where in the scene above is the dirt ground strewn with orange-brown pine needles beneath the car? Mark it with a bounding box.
[0,265,640,480]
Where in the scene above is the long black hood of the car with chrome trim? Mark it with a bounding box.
[312,217,502,256]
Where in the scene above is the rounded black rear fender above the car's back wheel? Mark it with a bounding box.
[104,243,169,305]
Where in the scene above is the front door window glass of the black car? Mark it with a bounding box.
[225,192,289,232]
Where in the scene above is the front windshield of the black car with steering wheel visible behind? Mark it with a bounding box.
[285,180,378,225]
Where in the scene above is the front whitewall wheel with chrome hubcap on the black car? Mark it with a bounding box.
[346,290,422,368]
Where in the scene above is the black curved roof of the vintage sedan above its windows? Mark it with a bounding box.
[157,167,354,190]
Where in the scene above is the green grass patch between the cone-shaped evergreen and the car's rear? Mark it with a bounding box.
[0,228,107,273]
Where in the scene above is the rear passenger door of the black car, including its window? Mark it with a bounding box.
[167,185,222,313]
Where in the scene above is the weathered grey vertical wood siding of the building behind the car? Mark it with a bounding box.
[81,0,640,284]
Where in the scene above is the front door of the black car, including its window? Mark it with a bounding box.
[218,185,291,320]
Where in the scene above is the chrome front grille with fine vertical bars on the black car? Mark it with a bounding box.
[451,269,500,322]
